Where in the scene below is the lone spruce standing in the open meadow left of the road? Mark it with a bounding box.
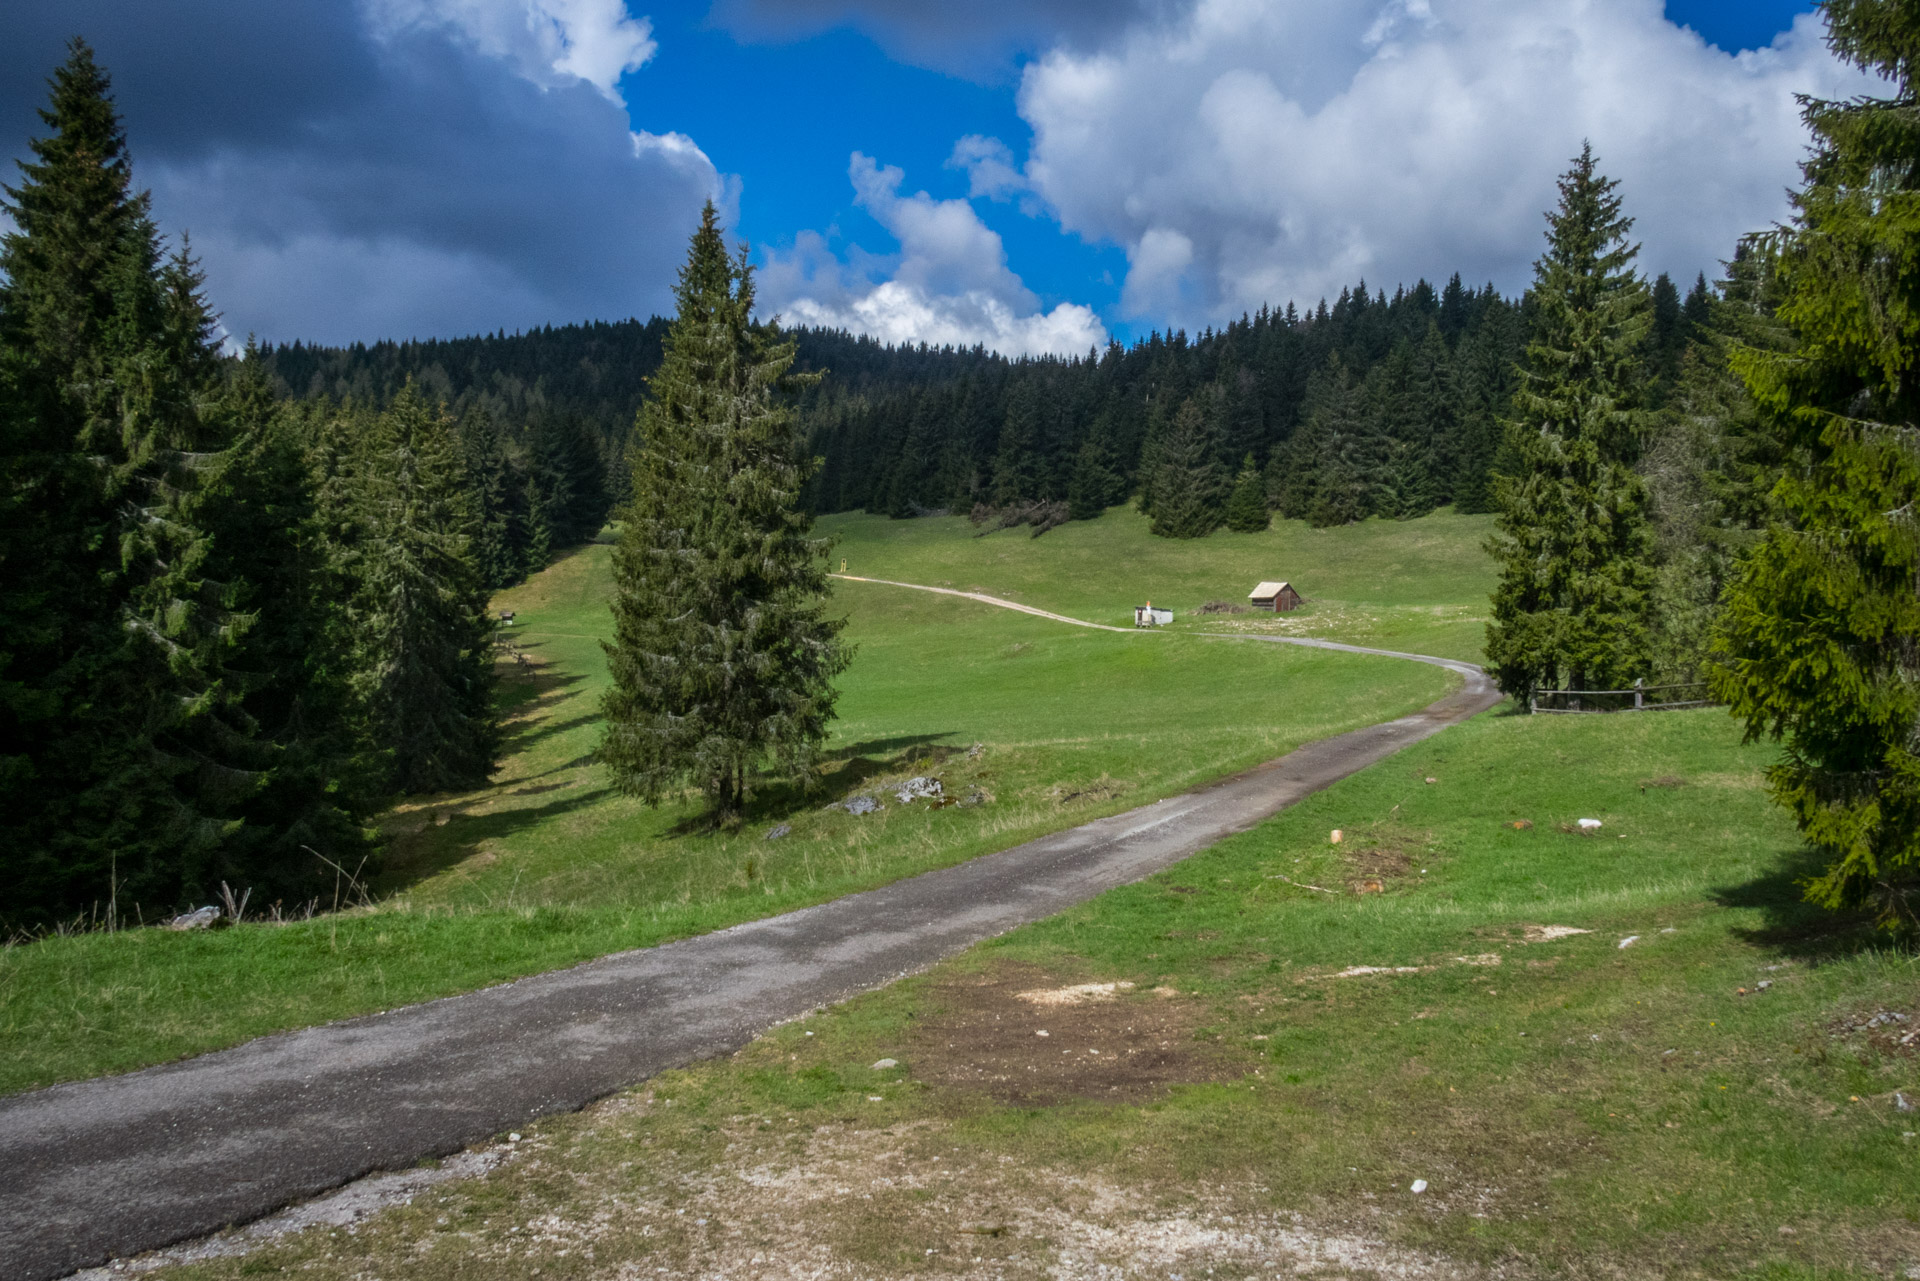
[599,204,851,822]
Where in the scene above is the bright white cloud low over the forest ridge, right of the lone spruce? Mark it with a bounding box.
[760,152,1106,355]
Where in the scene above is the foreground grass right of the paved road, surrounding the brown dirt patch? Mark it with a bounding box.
[190,713,1920,1279]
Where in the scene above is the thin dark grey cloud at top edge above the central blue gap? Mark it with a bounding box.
[710,0,1190,79]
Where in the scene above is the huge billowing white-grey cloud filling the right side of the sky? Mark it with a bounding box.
[1013,0,1866,325]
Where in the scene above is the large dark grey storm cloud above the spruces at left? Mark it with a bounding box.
[0,0,718,342]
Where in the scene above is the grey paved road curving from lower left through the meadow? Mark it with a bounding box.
[0,584,1500,1279]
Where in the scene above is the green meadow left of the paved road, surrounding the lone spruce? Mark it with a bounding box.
[0,513,1478,1091]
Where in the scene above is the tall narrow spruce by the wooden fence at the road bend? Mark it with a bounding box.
[1486,146,1653,697]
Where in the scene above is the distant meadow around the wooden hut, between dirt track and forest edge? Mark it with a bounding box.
[820,507,1494,659]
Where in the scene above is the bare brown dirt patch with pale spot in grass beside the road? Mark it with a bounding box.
[910,964,1242,1104]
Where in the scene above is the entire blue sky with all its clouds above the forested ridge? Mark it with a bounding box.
[0,0,1859,351]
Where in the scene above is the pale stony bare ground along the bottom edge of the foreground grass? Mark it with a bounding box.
[556,1099,1471,1281]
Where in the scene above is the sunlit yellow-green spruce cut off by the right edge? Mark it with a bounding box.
[1715,0,1920,930]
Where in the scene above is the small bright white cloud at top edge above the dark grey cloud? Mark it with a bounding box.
[365,0,659,102]
